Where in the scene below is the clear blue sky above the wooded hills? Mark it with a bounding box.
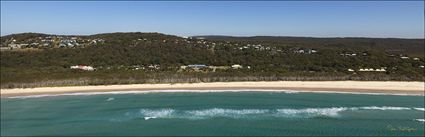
[1,1,424,38]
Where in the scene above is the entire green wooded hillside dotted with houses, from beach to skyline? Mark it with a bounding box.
[1,32,425,88]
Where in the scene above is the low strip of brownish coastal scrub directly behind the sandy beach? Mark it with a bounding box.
[1,72,420,88]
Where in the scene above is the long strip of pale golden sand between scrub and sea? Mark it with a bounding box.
[1,81,425,97]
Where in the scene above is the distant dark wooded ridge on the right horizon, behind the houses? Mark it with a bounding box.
[194,36,425,57]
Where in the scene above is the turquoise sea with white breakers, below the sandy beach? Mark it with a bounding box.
[1,92,425,136]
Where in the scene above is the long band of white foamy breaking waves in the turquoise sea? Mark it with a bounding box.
[112,106,421,120]
